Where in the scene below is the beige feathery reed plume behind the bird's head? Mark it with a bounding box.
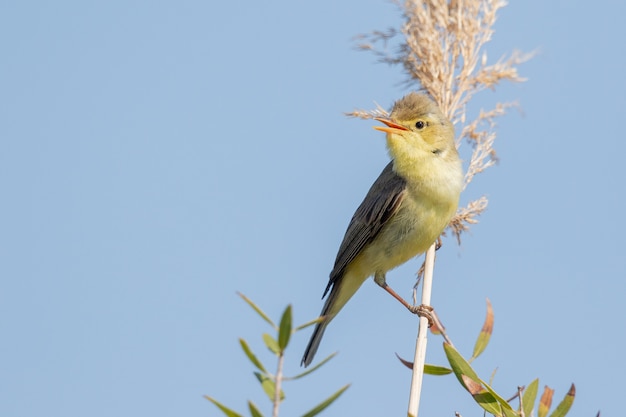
[348,0,533,244]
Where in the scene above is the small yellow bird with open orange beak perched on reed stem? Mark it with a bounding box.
[302,93,463,366]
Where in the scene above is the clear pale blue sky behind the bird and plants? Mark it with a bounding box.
[0,0,626,417]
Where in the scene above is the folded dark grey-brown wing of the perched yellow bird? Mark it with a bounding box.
[322,161,406,298]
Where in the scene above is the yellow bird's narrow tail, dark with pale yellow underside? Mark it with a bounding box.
[300,276,367,367]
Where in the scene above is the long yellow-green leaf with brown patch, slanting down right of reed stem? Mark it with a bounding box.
[443,343,513,415]
